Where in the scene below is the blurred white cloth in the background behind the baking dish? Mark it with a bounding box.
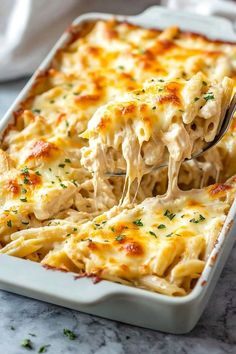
[0,0,236,81]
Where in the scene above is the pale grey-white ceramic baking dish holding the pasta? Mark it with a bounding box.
[0,6,236,334]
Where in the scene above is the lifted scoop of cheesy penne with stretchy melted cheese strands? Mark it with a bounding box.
[81,73,233,202]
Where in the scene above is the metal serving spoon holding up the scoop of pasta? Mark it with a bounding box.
[106,93,236,177]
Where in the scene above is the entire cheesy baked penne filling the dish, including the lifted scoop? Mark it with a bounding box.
[0,20,236,296]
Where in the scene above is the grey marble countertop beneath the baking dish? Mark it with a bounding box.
[0,80,236,354]
